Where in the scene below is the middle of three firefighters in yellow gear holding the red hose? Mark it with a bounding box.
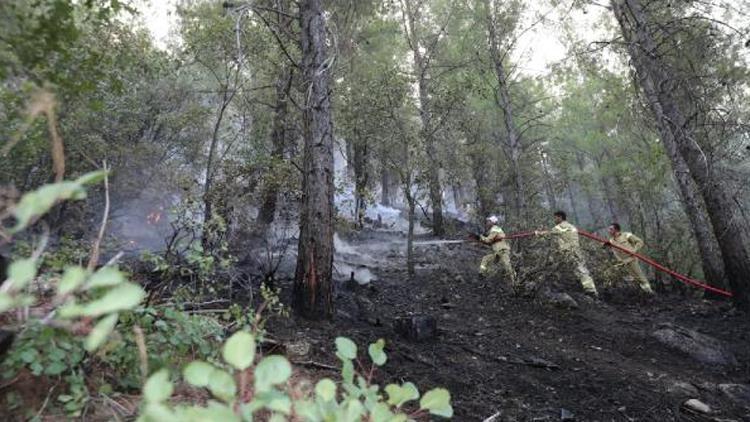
[534,211,599,298]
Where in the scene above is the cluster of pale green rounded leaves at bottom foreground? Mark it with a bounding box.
[139,331,453,422]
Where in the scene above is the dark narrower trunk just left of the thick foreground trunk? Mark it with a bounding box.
[258,65,292,226]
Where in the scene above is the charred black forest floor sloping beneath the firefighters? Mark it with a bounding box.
[268,229,750,421]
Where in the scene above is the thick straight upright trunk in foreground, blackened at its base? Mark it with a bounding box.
[293,0,334,318]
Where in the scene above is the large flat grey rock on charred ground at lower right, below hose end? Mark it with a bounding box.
[651,324,737,365]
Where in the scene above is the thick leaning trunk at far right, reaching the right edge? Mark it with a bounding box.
[611,0,750,309]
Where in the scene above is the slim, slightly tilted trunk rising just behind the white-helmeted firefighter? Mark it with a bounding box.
[484,0,527,226]
